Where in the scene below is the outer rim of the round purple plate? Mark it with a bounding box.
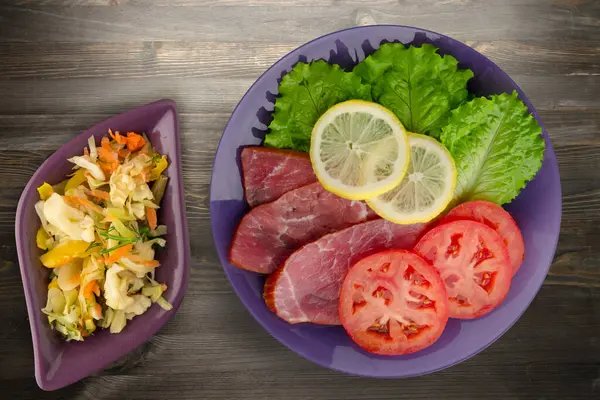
[209,24,562,379]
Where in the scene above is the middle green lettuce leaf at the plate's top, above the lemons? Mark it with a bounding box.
[353,43,473,137]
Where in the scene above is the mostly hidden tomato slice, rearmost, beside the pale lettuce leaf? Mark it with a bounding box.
[440,200,525,275]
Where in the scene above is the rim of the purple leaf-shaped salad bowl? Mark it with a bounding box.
[15,98,191,391]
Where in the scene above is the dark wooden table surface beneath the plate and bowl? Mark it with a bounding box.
[0,0,600,400]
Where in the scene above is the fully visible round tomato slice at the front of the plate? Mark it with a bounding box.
[340,250,448,355]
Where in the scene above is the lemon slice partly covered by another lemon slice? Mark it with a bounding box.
[367,133,456,224]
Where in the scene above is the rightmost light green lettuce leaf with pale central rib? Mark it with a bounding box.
[441,92,544,204]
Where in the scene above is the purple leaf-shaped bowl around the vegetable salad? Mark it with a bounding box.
[15,100,190,390]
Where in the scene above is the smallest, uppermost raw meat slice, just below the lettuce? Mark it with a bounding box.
[242,147,317,207]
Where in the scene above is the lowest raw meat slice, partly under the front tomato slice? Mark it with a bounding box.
[264,219,427,325]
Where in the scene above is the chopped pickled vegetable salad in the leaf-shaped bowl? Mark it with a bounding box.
[35,130,172,341]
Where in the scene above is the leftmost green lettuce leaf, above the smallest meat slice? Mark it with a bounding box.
[265,60,371,151]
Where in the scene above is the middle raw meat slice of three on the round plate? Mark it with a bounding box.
[229,182,377,274]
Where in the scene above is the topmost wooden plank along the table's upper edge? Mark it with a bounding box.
[0,0,598,45]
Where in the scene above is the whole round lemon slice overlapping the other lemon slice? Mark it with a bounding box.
[310,100,410,200]
